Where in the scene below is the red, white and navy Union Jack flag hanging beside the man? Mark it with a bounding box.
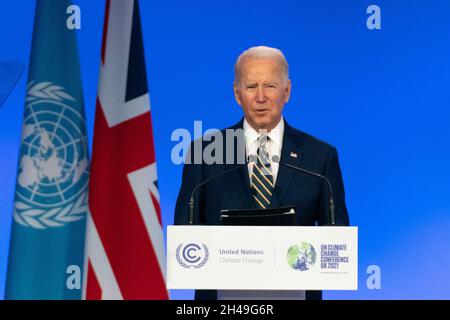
[84,0,168,299]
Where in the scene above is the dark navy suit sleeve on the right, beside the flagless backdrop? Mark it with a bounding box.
[319,147,350,226]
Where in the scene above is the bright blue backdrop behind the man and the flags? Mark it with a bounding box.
[0,0,450,299]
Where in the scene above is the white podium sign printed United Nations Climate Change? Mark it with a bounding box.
[167,226,358,290]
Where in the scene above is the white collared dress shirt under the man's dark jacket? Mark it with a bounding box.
[244,117,284,185]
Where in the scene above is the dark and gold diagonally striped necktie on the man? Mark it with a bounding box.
[252,135,274,209]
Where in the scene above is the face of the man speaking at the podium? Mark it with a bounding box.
[234,58,291,130]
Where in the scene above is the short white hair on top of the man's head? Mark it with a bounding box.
[234,46,289,84]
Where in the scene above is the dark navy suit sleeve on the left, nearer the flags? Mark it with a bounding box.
[174,142,202,225]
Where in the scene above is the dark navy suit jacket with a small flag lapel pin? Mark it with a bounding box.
[175,119,349,299]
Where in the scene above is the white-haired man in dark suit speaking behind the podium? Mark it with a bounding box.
[175,47,349,299]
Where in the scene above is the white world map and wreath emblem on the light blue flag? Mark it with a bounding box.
[14,81,89,229]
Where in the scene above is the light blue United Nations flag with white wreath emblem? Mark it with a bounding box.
[5,0,89,299]
